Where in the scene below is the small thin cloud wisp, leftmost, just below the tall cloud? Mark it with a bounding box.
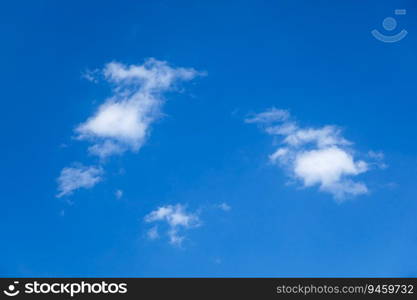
[57,164,103,198]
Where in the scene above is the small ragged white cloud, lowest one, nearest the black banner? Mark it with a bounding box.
[145,204,200,246]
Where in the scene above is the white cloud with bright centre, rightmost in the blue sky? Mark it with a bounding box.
[252,109,381,200]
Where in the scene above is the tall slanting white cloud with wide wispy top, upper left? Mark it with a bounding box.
[75,58,202,158]
